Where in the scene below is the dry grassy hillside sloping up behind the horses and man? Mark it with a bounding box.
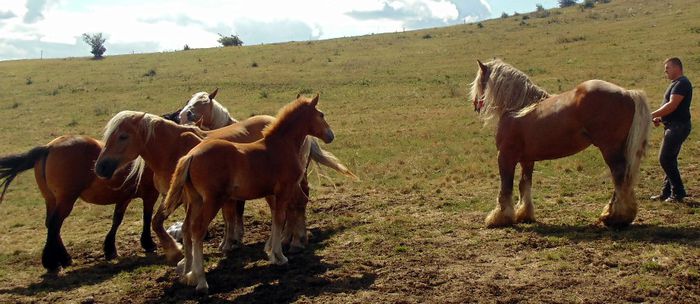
[0,0,700,303]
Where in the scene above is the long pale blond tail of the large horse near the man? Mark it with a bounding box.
[625,90,651,187]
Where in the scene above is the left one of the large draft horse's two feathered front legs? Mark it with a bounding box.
[486,151,517,228]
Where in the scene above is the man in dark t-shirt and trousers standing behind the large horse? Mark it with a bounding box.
[651,57,693,202]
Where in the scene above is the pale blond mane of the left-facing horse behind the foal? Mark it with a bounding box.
[102,111,206,189]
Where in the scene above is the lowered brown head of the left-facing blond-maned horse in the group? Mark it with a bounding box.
[95,111,153,179]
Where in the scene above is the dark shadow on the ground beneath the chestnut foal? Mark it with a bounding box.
[148,224,376,303]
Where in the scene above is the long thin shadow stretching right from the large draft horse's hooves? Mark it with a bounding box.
[516,223,700,247]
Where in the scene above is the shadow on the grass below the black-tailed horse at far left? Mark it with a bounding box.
[0,254,165,296]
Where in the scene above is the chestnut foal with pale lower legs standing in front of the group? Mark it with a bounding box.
[161,95,335,293]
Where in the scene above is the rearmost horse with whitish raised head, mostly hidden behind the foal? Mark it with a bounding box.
[170,88,357,252]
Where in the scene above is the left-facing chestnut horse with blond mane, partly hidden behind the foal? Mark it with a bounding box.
[95,104,354,262]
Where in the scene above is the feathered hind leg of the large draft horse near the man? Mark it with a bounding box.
[600,148,637,228]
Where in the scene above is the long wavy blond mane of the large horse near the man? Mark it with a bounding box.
[470,59,550,124]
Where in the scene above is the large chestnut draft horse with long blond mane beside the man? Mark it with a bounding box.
[470,59,651,228]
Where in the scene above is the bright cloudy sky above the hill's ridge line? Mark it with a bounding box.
[0,0,558,60]
